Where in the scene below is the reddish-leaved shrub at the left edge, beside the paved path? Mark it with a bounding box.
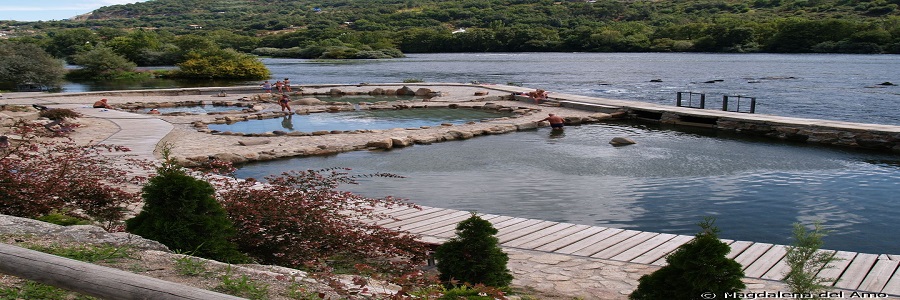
[0,120,148,230]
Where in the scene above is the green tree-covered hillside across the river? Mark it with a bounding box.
[1,0,900,57]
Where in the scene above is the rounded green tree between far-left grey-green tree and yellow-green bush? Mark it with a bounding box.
[72,46,136,78]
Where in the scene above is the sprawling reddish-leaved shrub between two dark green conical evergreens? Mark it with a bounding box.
[205,168,427,295]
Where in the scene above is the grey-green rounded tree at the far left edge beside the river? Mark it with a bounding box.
[0,42,66,86]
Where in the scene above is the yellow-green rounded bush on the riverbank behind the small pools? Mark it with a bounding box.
[173,49,269,80]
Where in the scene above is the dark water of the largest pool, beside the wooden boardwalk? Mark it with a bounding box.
[238,125,900,253]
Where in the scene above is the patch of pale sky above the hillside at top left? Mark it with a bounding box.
[0,0,147,21]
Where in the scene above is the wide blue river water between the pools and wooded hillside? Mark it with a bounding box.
[64,53,900,125]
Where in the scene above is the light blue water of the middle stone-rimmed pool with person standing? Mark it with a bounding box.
[209,108,512,133]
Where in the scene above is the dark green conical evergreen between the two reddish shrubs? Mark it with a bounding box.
[125,161,247,262]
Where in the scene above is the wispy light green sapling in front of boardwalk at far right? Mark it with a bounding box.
[784,222,835,299]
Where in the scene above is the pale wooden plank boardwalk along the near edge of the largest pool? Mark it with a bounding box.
[378,207,900,296]
